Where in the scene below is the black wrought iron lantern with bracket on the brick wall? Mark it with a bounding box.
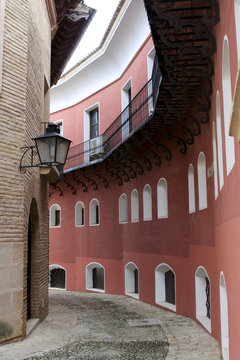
[20,123,71,173]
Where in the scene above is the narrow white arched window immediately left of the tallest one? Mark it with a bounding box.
[216,91,224,190]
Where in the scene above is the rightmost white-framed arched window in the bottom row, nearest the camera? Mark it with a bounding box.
[219,272,229,360]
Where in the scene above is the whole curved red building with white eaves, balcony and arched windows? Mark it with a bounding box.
[49,0,240,359]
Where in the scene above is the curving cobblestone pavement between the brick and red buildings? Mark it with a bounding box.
[0,291,221,360]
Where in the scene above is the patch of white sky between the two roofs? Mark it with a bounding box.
[64,0,119,72]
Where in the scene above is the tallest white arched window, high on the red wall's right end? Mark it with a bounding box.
[222,36,235,175]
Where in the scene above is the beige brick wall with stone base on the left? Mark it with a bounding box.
[0,0,51,342]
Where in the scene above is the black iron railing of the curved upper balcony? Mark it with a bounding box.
[64,60,162,172]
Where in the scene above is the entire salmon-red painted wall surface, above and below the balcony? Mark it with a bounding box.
[50,0,240,360]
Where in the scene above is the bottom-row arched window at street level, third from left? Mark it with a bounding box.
[125,262,139,299]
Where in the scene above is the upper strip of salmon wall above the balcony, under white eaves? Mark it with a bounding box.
[51,37,153,146]
